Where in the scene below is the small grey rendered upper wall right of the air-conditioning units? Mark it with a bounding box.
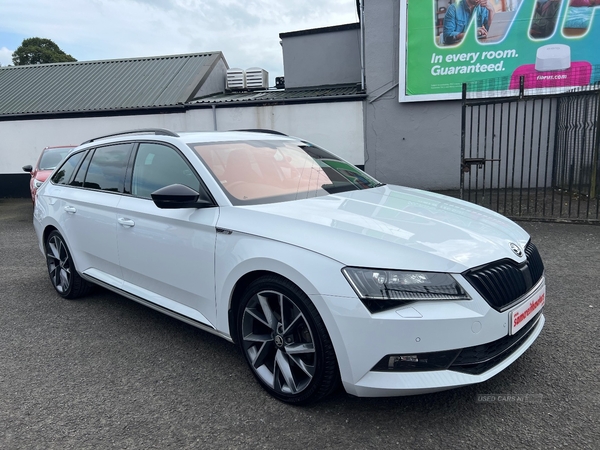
[280,25,360,89]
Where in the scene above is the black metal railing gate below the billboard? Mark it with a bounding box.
[460,80,600,223]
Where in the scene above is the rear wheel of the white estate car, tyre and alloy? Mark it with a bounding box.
[44,230,91,299]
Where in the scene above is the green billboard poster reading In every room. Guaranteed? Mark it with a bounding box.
[399,0,600,102]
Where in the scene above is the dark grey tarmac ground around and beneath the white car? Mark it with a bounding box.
[0,199,600,450]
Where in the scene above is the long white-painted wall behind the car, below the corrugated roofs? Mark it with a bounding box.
[0,102,364,174]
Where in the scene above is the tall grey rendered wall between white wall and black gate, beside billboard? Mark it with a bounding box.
[364,0,461,190]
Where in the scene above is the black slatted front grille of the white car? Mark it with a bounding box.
[463,242,544,311]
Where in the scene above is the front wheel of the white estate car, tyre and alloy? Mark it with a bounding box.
[237,276,339,405]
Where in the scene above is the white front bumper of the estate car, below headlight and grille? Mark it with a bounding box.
[316,277,545,397]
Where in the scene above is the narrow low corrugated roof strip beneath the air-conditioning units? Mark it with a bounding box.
[190,85,366,105]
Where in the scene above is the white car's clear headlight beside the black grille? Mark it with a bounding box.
[342,267,471,312]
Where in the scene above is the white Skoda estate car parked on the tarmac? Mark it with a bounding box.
[34,130,545,404]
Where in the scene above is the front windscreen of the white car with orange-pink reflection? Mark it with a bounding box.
[190,140,381,205]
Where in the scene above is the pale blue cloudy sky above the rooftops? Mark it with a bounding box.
[0,0,358,81]
